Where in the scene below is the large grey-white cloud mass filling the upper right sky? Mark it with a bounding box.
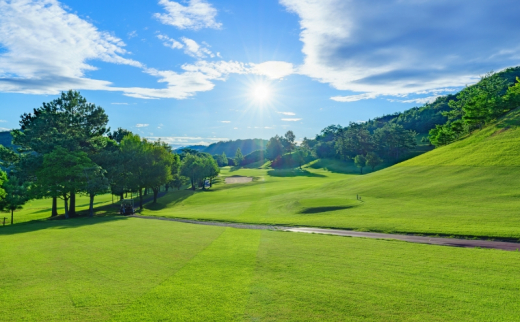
[280,0,520,98]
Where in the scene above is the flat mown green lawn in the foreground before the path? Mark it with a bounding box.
[0,217,520,321]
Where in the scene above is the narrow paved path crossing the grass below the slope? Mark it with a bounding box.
[130,215,520,251]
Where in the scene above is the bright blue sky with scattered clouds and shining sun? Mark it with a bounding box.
[0,0,520,147]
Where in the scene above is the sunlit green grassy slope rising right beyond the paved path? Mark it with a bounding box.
[143,111,520,239]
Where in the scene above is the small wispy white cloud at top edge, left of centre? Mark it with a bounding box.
[154,0,222,30]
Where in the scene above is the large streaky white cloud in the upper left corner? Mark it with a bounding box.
[0,0,142,83]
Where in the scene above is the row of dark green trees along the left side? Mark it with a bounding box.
[0,91,219,222]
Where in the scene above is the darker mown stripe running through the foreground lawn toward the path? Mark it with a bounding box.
[113,228,262,321]
